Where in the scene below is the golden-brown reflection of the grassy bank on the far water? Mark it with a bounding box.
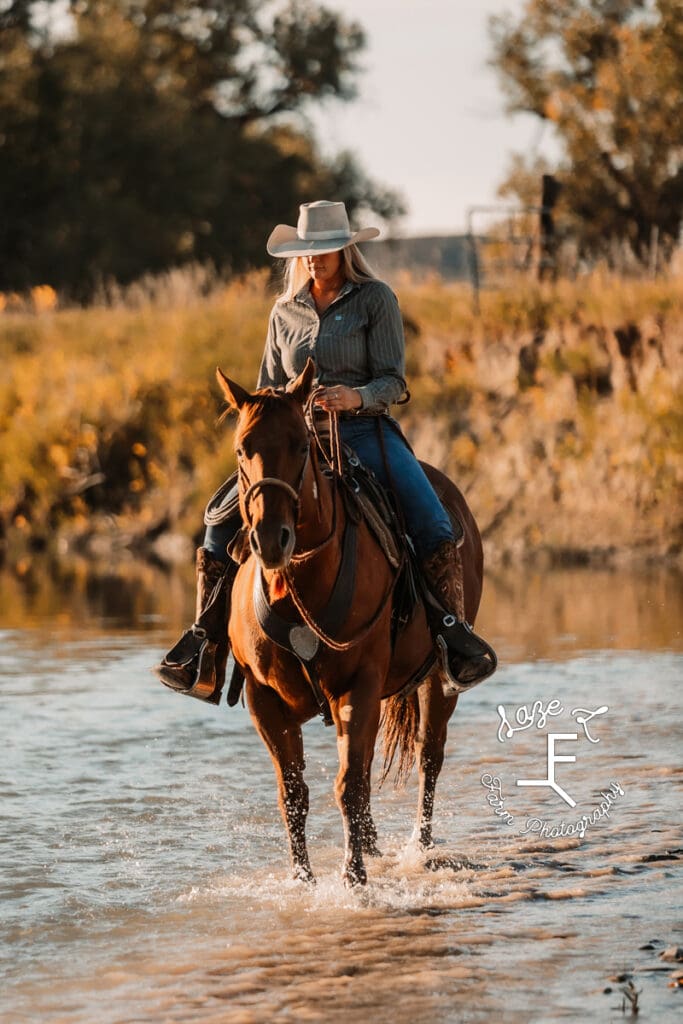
[0,559,683,660]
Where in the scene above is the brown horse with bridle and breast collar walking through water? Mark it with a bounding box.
[217,360,483,885]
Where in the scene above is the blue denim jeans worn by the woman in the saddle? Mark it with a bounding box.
[204,416,454,562]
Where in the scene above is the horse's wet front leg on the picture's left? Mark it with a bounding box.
[247,681,315,882]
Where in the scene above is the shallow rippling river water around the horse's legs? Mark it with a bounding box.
[0,567,683,1024]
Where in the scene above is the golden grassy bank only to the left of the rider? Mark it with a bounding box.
[0,276,269,534]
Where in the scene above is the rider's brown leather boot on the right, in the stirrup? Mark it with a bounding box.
[423,541,498,696]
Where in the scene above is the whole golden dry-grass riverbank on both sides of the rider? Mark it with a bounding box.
[0,269,683,561]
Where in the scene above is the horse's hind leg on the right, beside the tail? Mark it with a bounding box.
[413,676,458,850]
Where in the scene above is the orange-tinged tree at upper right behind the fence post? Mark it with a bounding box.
[492,0,683,260]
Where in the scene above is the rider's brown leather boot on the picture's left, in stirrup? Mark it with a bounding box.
[153,548,238,703]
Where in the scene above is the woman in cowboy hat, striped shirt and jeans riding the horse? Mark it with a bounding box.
[155,201,492,699]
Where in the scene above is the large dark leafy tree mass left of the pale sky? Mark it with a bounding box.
[0,0,401,297]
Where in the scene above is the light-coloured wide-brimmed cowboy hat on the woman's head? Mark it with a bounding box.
[266,200,380,257]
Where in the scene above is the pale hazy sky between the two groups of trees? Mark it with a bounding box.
[311,0,552,236]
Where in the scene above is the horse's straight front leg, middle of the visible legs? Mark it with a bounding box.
[332,680,380,886]
